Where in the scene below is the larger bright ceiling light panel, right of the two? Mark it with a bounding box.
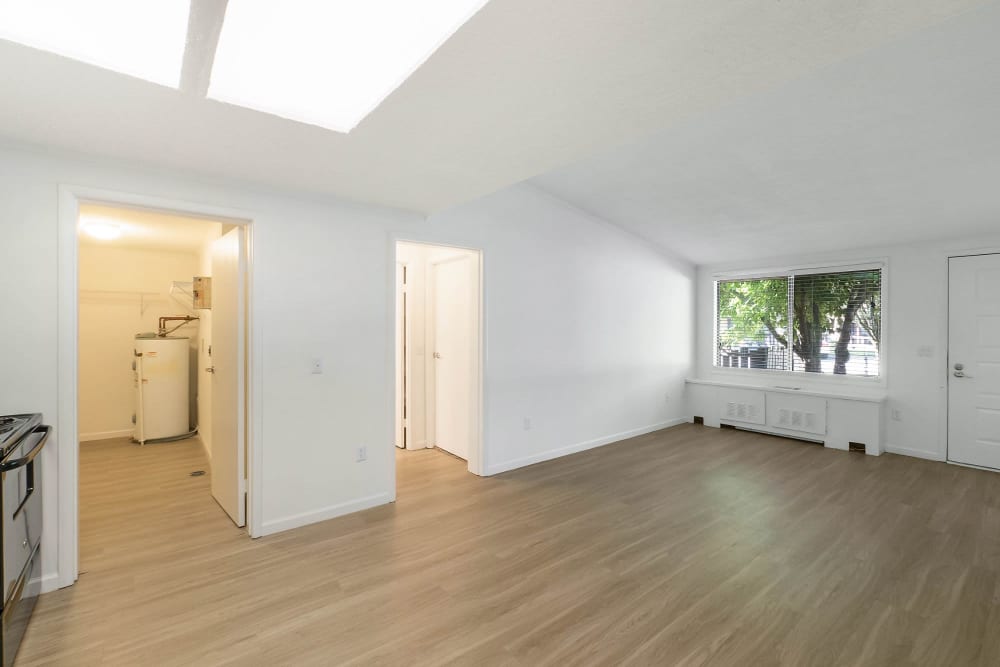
[209,0,487,132]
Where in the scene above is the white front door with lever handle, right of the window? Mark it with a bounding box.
[948,255,1000,469]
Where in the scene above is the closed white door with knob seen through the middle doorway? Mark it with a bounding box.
[432,256,474,460]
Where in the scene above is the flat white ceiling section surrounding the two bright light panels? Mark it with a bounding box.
[0,0,984,212]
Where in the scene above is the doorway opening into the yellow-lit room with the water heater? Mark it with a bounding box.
[76,203,249,569]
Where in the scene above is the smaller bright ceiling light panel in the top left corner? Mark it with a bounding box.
[0,0,191,88]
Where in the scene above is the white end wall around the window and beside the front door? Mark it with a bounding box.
[697,235,1000,460]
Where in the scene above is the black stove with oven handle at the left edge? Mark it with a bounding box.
[0,414,52,667]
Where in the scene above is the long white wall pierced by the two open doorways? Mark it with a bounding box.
[0,146,694,588]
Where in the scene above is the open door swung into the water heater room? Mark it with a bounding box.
[211,228,246,526]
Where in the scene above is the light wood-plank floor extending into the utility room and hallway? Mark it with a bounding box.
[18,425,1000,666]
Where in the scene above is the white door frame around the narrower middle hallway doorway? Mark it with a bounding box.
[386,237,489,488]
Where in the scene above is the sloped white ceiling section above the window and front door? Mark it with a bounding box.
[533,3,1000,263]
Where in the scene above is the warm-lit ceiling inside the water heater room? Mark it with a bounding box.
[79,204,222,253]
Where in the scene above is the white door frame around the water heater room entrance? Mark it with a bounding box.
[56,184,263,592]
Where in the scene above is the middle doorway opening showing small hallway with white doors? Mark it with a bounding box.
[394,241,484,475]
